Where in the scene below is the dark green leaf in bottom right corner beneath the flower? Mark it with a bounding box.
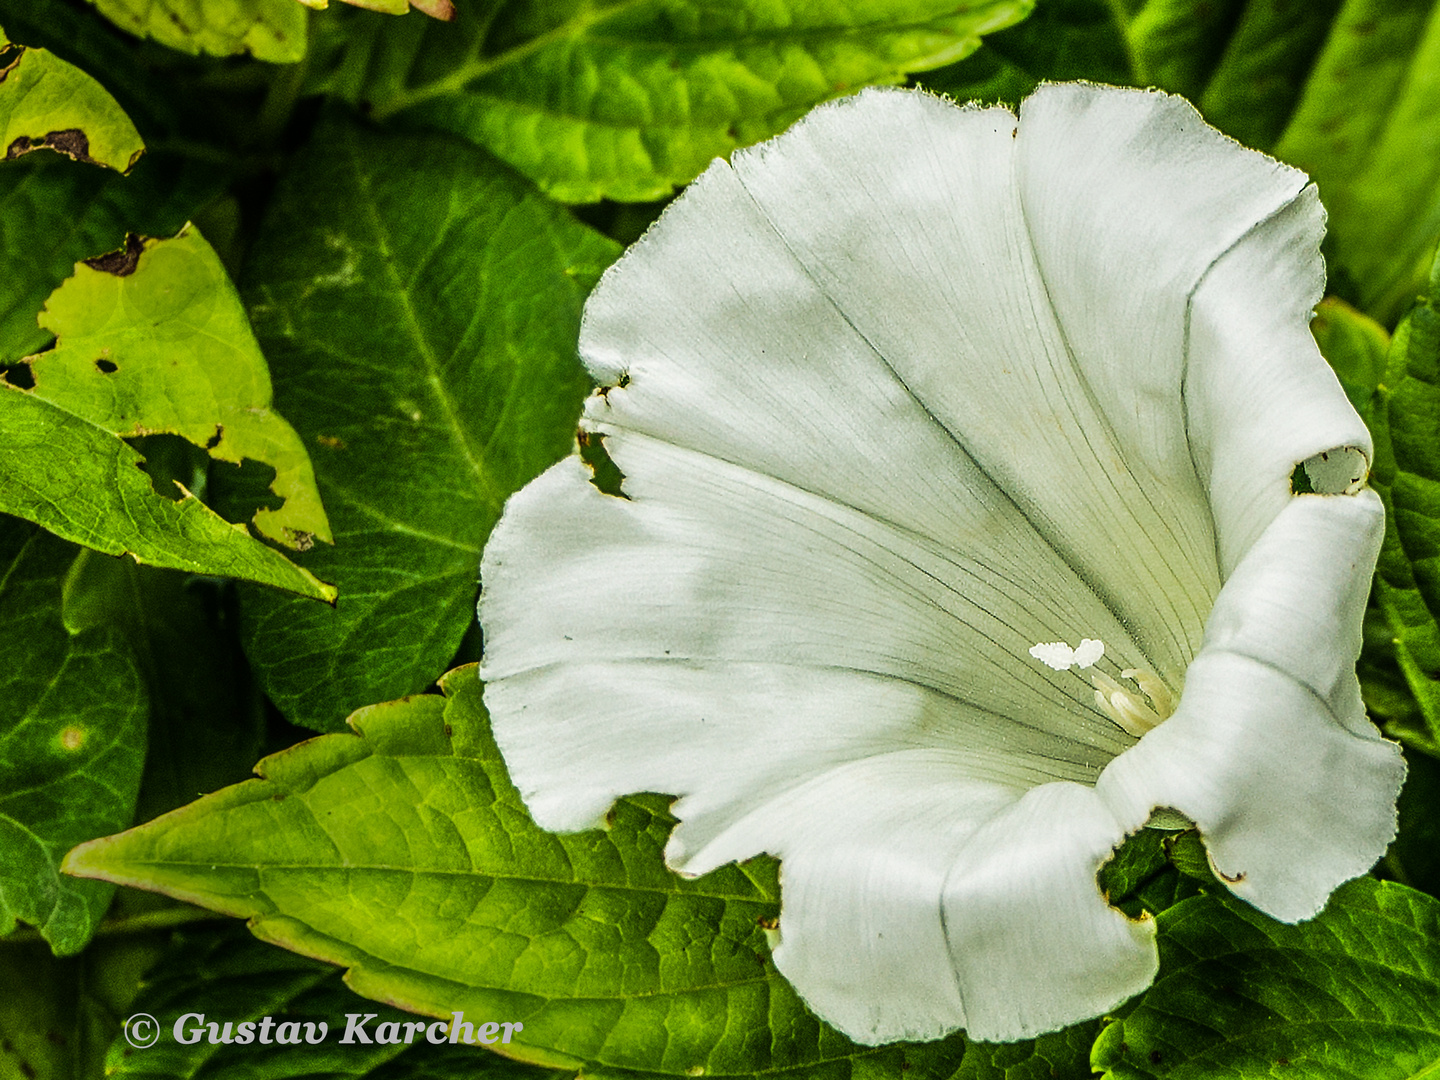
[1093,878,1440,1080]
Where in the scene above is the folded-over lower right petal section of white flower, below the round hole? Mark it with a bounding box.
[1097,491,1404,922]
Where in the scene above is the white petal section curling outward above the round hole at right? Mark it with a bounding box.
[1185,187,1371,575]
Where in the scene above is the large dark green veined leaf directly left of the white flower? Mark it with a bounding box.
[233,110,619,730]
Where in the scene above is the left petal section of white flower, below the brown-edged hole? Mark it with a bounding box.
[481,433,1142,766]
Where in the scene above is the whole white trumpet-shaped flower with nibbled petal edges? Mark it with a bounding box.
[481,85,1404,1043]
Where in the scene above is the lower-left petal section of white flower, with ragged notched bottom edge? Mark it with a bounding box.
[485,660,1097,852]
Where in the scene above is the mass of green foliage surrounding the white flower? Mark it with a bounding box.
[0,0,1440,1080]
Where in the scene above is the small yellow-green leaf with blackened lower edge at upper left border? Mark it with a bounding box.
[0,23,145,173]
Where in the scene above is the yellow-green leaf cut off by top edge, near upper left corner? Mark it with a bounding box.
[82,0,305,63]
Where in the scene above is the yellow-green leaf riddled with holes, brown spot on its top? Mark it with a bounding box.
[27,226,331,550]
